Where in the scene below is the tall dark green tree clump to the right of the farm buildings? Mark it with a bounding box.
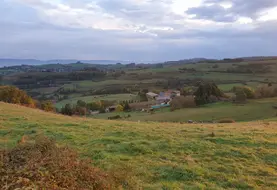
[194,83,225,105]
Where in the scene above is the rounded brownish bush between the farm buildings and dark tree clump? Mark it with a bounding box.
[170,96,196,111]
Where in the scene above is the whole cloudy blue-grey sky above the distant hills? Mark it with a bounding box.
[0,0,277,61]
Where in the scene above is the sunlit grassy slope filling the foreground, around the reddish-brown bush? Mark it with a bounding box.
[0,102,277,189]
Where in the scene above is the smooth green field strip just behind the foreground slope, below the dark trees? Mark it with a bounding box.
[94,98,277,122]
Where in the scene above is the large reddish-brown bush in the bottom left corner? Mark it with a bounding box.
[0,137,119,190]
